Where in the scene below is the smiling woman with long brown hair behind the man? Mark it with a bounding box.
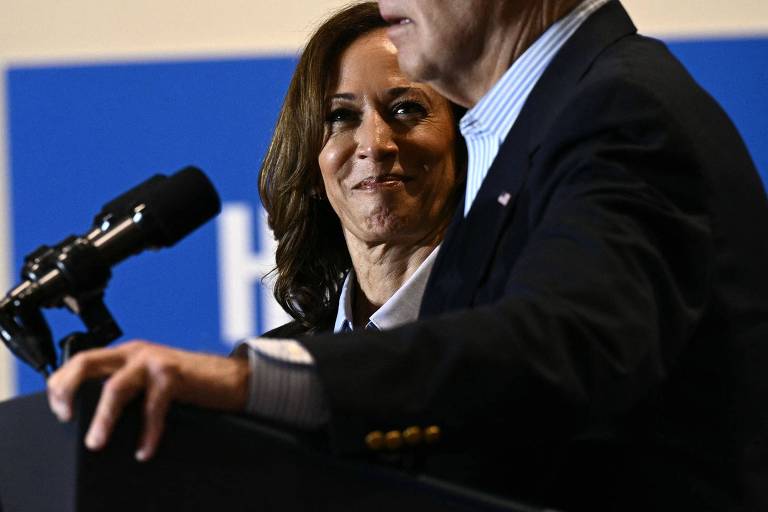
[260,3,464,330]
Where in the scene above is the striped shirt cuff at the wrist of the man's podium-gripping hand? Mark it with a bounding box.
[233,338,329,429]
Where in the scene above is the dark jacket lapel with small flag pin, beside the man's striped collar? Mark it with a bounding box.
[421,1,636,316]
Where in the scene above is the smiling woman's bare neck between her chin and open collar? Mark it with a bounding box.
[347,237,440,327]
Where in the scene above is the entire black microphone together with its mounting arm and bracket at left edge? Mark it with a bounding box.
[0,167,221,376]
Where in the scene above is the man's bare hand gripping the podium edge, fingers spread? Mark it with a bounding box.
[48,341,249,461]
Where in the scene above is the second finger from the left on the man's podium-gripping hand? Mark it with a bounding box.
[85,363,146,450]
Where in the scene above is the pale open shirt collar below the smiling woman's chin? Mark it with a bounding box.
[333,246,440,332]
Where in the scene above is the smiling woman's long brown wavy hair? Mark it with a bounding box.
[259,2,459,327]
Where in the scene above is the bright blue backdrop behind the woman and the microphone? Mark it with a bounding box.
[6,39,768,393]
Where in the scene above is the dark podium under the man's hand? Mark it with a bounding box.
[0,385,534,512]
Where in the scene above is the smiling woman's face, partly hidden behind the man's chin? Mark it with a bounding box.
[319,29,457,245]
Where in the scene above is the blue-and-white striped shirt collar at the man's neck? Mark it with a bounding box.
[459,0,610,144]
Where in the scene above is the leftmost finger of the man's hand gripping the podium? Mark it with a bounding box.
[47,349,125,421]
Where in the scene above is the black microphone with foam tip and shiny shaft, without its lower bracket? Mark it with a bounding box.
[0,167,221,368]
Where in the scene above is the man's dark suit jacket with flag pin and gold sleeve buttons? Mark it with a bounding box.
[292,1,768,511]
